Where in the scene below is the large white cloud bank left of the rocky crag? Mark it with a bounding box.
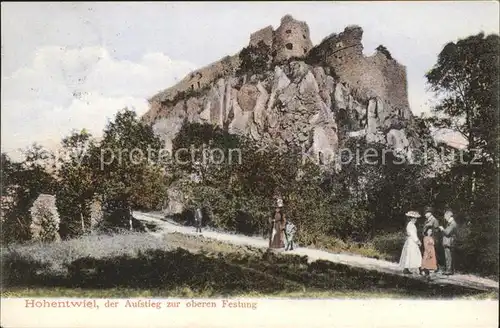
[2,46,195,159]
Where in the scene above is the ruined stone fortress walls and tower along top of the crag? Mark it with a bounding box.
[148,15,412,125]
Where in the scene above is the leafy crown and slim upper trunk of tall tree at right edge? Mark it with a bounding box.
[426,33,500,202]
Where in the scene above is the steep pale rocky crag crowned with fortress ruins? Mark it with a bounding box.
[143,15,416,163]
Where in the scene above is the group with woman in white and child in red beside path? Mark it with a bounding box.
[399,207,457,277]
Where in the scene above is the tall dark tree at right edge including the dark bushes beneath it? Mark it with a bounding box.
[426,33,500,274]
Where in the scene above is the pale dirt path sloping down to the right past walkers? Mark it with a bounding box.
[134,212,498,292]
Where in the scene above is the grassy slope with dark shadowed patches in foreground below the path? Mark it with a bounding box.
[1,229,496,299]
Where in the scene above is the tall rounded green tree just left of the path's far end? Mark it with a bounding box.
[95,109,165,230]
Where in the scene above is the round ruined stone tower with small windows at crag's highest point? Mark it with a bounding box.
[272,15,312,62]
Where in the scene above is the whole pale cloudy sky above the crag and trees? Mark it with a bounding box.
[1,1,499,157]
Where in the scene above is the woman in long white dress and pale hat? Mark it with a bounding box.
[399,211,422,274]
